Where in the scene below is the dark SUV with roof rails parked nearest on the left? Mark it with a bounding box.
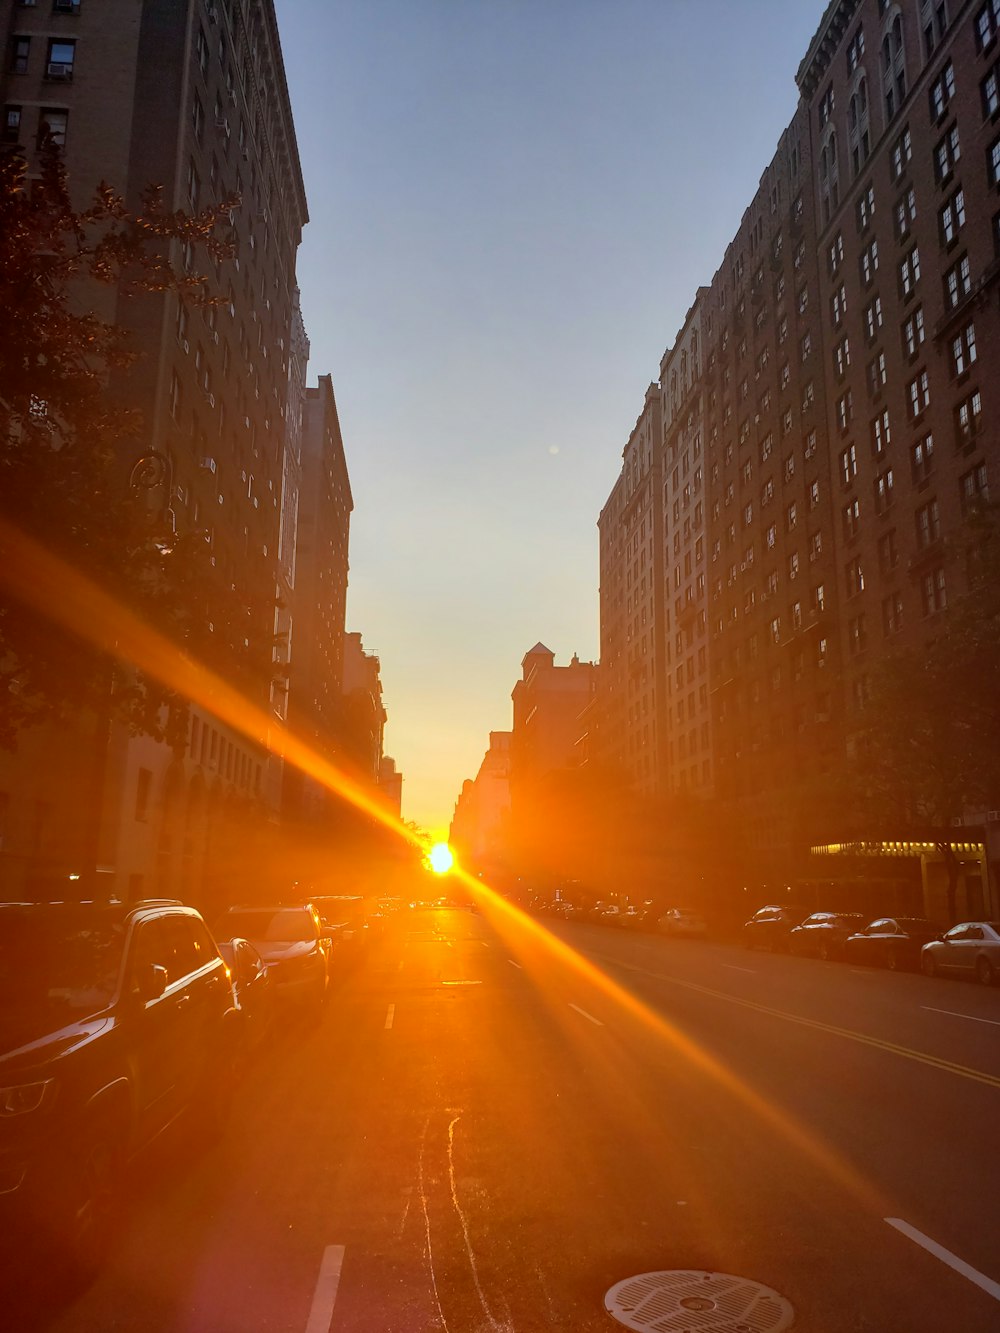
[0,901,236,1276]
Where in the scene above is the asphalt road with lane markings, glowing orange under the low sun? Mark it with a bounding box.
[13,905,1000,1333]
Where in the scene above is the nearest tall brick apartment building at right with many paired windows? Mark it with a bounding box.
[797,0,1000,738]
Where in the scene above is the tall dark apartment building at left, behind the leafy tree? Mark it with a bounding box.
[0,0,308,905]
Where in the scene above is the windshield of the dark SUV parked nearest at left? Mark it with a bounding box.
[0,904,125,1050]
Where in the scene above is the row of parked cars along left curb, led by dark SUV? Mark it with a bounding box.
[0,897,372,1280]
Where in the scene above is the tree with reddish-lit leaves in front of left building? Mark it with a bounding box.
[0,140,245,748]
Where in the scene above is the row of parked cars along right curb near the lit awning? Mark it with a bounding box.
[743,905,1000,986]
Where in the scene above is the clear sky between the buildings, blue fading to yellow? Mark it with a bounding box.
[276,0,825,833]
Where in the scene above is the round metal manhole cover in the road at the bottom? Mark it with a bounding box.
[604,1269,795,1333]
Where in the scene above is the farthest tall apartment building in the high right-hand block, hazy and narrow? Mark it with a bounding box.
[596,384,664,794]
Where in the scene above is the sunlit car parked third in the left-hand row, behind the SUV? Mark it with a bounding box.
[216,902,331,1013]
